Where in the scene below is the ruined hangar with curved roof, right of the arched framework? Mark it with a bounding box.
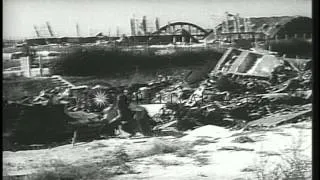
[211,13,312,41]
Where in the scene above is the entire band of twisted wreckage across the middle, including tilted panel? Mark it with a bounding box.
[3,48,312,150]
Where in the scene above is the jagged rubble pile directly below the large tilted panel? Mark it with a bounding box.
[154,50,312,130]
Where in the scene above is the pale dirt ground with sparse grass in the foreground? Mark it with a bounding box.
[3,120,312,180]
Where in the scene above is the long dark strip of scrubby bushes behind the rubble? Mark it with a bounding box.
[51,49,221,76]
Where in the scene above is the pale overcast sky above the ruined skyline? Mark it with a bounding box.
[3,0,312,38]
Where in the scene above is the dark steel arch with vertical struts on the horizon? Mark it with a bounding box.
[151,22,209,36]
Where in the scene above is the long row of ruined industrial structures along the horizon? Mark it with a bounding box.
[21,12,312,45]
